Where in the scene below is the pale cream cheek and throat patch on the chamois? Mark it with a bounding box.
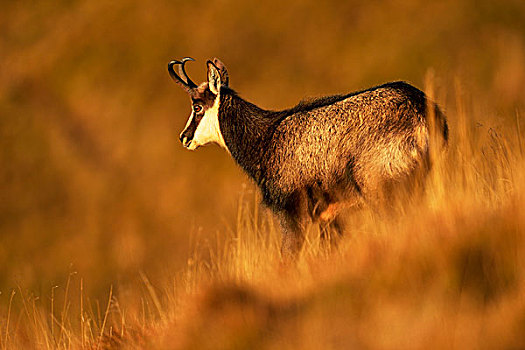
[188,95,228,150]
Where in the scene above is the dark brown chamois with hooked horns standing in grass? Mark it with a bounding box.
[168,57,448,257]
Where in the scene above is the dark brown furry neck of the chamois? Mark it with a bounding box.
[219,87,275,182]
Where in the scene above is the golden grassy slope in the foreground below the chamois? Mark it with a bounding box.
[0,76,525,349]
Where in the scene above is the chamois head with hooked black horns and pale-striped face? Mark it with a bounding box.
[168,57,229,150]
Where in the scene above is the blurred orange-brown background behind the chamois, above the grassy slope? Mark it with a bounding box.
[0,0,525,303]
